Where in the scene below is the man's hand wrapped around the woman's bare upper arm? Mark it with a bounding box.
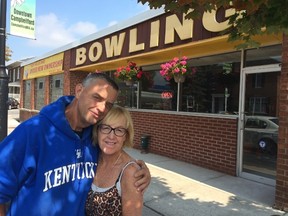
[134,160,151,194]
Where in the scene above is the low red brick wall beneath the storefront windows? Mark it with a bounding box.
[131,110,237,176]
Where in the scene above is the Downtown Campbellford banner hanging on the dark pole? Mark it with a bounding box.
[10,0,36,39]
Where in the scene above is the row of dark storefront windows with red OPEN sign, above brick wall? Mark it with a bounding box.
[118,52,241,114]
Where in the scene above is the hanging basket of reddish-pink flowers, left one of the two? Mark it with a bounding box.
[114,62,143,85]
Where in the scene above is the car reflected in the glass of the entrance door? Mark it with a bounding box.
[244,116,279,155]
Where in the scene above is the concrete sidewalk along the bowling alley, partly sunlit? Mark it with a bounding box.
[8,115,288,216]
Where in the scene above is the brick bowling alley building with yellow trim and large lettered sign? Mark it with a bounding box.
[20,10,288,209]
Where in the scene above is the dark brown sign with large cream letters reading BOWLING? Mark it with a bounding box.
[70,8,235,68]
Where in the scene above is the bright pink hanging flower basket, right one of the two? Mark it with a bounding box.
[160,56,188,83]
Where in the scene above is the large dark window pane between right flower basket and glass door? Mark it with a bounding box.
[180,60,240,114]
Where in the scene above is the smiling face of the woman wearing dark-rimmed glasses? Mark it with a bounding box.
[98,117,127,155]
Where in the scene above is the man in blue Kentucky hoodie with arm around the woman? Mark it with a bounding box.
[0,73,151,216]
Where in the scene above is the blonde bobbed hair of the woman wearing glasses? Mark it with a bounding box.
[93,105,134,147]
